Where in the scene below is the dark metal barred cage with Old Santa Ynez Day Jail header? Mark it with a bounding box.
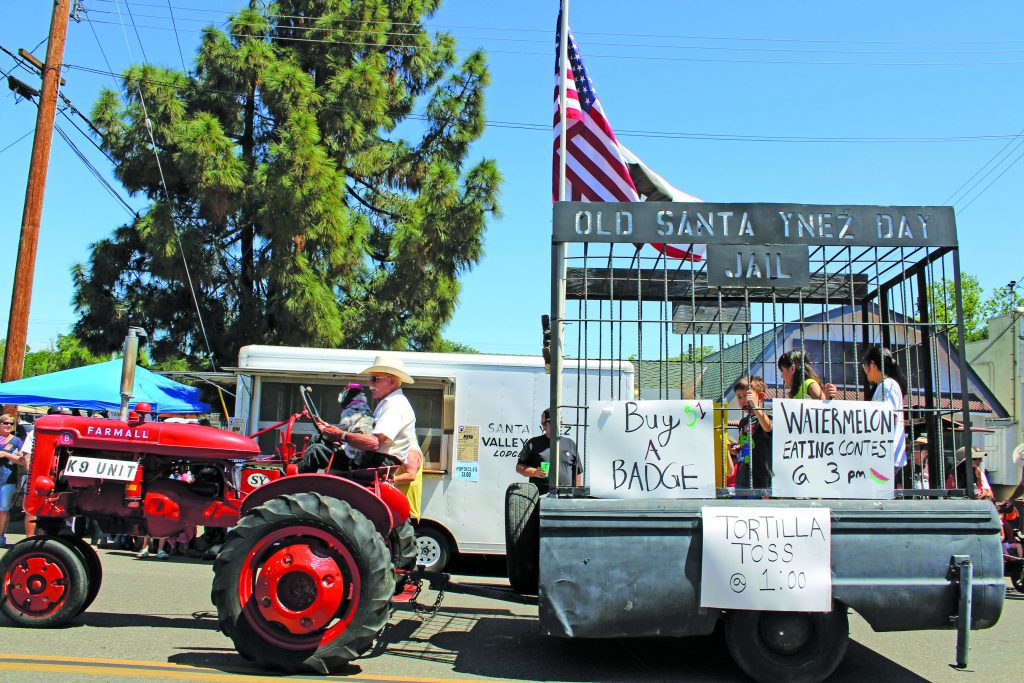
[551,202,978,498]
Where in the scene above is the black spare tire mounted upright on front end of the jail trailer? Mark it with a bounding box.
[505,481,541,594]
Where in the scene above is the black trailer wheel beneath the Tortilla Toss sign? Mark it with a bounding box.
[725,603,850,683]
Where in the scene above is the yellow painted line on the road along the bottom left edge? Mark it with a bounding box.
[0,653,481,683]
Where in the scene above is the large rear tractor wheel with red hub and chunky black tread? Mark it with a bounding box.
[211,494,394,674]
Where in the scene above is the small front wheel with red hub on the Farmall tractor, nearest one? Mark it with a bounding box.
[0,537,88,628]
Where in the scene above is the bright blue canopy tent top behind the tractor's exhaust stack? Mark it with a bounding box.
[0,359,210,413]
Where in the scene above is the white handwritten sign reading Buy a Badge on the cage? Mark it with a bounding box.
[587,400,715,498]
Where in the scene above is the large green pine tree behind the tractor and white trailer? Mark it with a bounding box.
[73,0,501,362]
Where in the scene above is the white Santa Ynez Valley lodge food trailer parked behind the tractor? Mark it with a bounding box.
[234,346,634,570]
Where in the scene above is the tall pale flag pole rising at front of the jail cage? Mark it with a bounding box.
[548,0,575,490]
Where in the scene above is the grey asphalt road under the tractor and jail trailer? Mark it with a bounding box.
[0,536,1024,683]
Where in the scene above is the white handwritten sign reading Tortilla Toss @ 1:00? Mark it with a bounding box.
[700,507,831,612]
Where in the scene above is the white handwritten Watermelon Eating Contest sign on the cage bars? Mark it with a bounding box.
[772,398,900,500]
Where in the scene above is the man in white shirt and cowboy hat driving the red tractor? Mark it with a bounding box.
[317,353,423,519]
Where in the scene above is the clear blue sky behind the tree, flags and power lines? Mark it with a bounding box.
[0,0,1024,360]
